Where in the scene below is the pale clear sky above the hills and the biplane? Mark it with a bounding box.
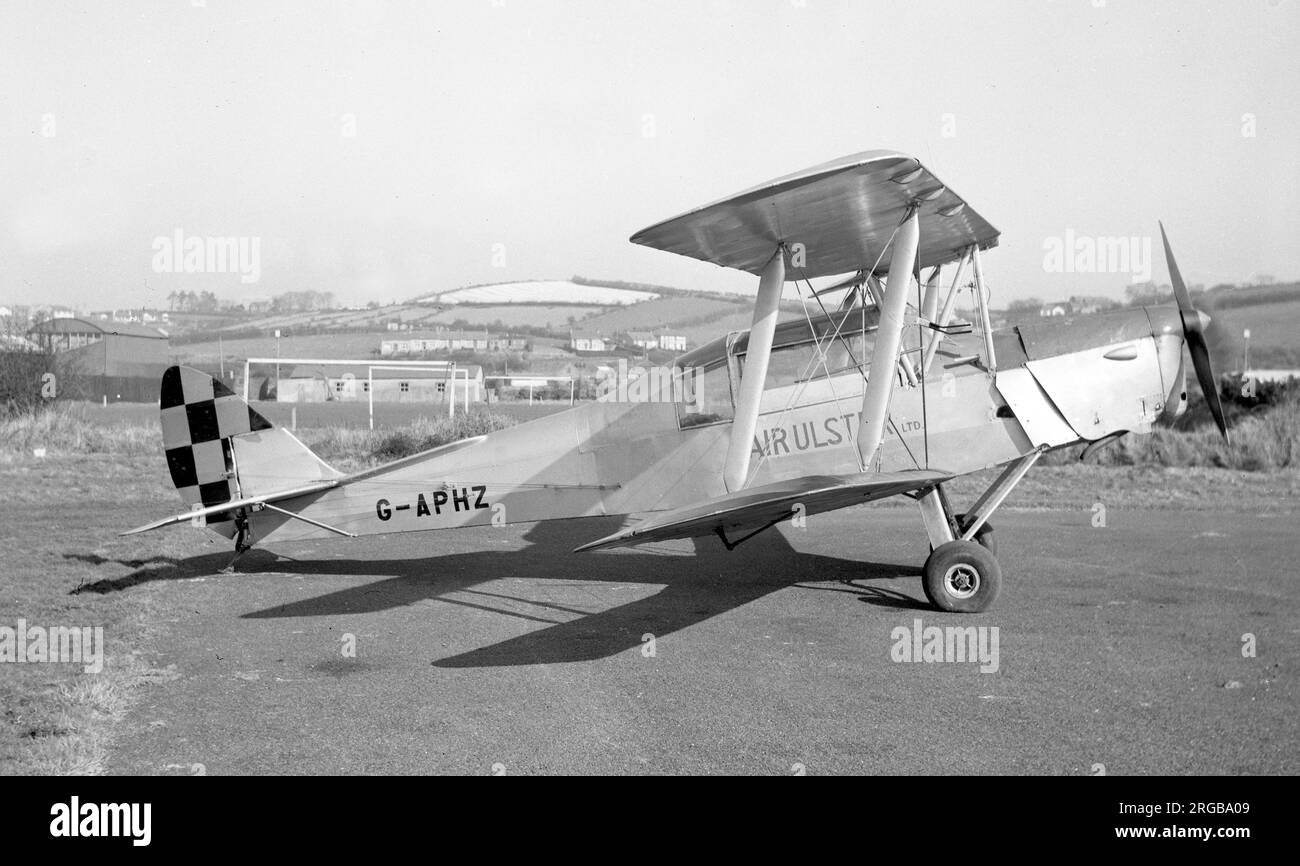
[0,0,1300,309]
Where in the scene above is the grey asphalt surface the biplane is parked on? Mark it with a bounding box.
[109,507,1300,775]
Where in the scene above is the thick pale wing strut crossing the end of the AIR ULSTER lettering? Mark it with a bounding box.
[858,207,920,469]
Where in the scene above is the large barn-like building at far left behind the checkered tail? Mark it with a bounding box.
[27,317,170,402]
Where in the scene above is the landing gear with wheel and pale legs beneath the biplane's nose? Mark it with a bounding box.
[917,451,1043,614]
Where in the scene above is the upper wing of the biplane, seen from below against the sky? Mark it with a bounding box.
[632,151,998,280]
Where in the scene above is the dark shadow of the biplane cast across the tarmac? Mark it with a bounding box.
[78,519,926,668]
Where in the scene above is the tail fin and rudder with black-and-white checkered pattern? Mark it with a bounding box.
[159,367,342,524]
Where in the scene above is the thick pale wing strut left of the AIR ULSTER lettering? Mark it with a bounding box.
[723,247,785,493]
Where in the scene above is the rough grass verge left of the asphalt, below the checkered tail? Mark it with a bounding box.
[0,454,194,775]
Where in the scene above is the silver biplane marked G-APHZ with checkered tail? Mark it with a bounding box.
[127,151,1227,612]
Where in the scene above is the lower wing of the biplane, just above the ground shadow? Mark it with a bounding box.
[575,469,953,553]
